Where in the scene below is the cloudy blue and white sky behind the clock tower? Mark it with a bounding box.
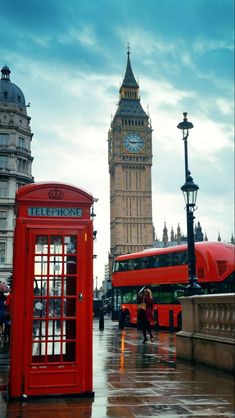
[0,0,234,284]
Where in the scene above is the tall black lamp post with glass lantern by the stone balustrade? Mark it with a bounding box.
[177,112,201,295]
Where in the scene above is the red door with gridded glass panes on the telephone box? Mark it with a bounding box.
[24,227,90,395]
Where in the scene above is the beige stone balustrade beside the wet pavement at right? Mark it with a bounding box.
[176,293,235,372]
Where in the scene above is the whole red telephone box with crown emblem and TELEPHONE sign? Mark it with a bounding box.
[9,183,94,397]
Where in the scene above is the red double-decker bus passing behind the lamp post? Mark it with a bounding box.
[112,241,235,329]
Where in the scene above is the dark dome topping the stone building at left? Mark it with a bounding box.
[0,65,25,107]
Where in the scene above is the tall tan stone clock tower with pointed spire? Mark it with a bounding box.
[108,47,154,262]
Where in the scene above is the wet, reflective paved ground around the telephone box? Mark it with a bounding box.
[0,318,235,418]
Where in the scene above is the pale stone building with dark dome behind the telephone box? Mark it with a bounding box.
[0,65,33,281]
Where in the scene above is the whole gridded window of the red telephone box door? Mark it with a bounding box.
[32,235,77,363]
